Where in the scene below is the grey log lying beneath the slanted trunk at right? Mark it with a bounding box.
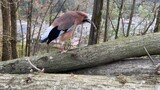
[72,56,160,76]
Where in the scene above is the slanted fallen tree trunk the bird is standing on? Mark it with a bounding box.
[0,33,160,73]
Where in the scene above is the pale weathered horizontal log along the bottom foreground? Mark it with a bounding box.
[0,73,160,90]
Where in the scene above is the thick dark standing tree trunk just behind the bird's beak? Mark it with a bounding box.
[88,0,103,45]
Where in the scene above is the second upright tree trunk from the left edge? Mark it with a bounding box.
[9,0,18,59]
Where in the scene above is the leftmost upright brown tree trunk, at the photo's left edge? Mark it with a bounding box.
[1,0,11,61]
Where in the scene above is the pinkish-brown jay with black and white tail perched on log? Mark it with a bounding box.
[40,11,96,52]
